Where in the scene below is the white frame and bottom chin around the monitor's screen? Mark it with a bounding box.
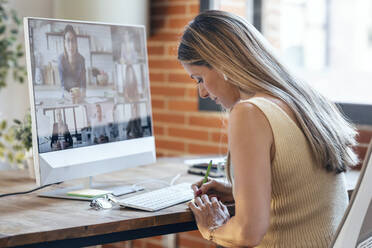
[23,17,156,186]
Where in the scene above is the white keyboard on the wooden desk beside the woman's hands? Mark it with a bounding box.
[119,183,194,212]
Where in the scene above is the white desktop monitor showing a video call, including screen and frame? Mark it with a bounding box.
[24,17,156,200]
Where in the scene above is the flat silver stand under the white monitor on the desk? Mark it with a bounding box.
[38,177,144,201]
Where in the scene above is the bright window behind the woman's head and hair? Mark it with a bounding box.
[201,0,372,125]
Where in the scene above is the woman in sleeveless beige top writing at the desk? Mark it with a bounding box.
[178,11,358,248]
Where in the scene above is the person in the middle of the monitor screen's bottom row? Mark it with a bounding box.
[92,104,110,144]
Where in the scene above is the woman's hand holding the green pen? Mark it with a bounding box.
[191,178,234,203]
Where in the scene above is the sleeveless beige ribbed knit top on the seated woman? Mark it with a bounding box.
[232,97,348,248]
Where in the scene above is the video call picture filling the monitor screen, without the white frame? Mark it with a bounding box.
[28,18,152,153]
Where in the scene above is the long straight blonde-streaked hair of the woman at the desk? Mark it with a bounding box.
[178,10,358,181]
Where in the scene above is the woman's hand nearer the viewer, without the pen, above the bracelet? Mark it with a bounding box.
[189,195,230,240]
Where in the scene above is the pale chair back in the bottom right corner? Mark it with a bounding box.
[329,141,372,248]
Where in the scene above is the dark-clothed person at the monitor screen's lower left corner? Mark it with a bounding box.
[50,109,73,150]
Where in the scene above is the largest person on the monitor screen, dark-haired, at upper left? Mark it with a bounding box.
[58,25,86,102]
